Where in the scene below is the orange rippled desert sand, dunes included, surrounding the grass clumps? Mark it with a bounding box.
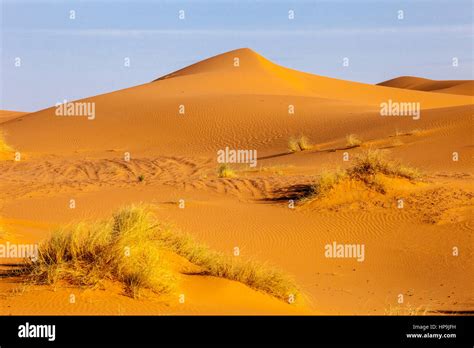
[0,49,474,315]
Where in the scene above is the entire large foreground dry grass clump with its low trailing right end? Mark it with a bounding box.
[21,206,299,301]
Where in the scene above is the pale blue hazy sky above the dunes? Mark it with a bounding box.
[0,0,474,111]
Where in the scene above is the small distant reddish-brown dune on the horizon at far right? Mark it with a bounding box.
[378,76,474,96]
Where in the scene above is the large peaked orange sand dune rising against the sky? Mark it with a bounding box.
[3,48,472,155]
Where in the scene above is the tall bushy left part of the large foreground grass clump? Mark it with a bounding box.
[22,206,176,297]
